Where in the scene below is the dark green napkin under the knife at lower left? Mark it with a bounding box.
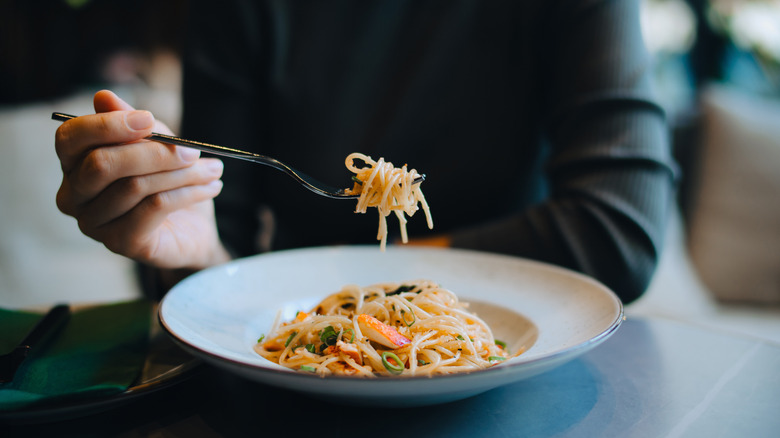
[0,300,152,411]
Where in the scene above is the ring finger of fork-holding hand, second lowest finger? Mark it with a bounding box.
[78,158,223,231]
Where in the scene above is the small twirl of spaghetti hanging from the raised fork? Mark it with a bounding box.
[345,152,433,251]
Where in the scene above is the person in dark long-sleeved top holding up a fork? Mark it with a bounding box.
[55,0,676,303]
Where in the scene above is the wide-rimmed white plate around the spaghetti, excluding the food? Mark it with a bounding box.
[159,245,623,406]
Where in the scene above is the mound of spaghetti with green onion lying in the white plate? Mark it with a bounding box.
[255,281,522,377]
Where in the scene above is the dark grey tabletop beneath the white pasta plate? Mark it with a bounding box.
[0,318,780,438]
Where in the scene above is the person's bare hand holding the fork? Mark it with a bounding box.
[55,90,229,269]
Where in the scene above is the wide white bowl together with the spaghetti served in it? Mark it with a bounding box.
[158,245,623,407]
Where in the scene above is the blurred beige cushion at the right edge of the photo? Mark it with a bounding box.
[688,85,780,304]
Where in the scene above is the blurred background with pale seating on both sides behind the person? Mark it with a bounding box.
[0,0,780,342]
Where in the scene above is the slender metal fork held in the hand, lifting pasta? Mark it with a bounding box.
[51,112,425,199]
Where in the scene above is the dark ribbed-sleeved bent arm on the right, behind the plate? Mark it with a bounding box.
[452,1,674,302]
